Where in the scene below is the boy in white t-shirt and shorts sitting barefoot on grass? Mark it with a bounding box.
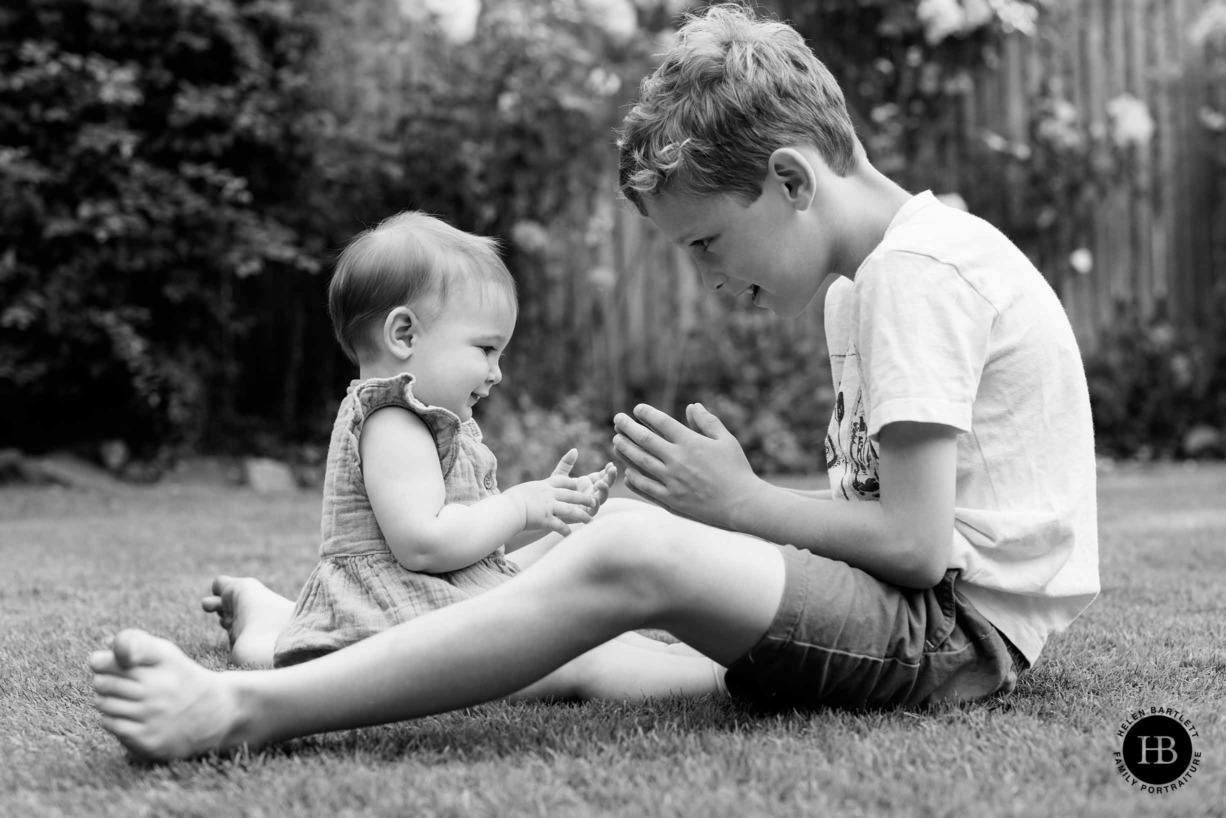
[91,6,1098,758]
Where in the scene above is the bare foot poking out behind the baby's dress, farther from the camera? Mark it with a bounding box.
[201,576,294,667]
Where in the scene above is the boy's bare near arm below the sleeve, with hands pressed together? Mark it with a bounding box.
[614,406,958,587]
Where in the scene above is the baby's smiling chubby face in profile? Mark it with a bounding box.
[407,286,516,421]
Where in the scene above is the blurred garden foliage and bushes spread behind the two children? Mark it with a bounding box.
[0,0,1226,482]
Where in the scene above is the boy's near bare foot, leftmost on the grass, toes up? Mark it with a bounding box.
[89,630,242,760]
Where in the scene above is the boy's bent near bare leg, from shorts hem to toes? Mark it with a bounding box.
[89,513,783,758]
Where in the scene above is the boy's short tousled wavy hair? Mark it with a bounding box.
[618,4,857,215]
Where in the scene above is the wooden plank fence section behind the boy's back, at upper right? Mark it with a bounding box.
[948,0,1226,348]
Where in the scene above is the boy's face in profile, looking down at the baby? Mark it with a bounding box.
[645,184,834,318]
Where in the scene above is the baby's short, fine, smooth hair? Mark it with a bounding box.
[327,211,516,363]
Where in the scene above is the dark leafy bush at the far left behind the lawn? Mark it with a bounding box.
[0,0,318,458]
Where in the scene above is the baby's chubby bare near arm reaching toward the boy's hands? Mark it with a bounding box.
[359,407,592,574]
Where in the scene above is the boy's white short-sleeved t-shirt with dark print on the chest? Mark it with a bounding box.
[825,193,1098,663]
